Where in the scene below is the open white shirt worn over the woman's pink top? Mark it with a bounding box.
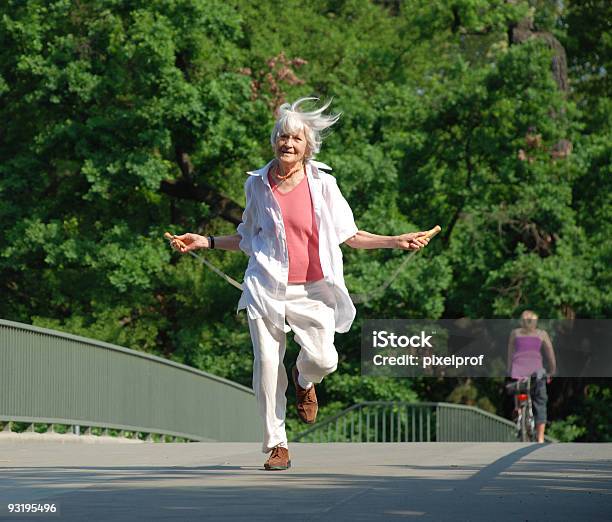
[236,160,358,333]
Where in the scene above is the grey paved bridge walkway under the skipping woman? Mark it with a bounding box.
[0,441,612,522]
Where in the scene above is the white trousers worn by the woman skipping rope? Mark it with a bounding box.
[249,279,338,453]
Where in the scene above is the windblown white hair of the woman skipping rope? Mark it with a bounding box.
[270,98,340,160]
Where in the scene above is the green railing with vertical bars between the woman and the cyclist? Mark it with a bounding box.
[293,401,540,442]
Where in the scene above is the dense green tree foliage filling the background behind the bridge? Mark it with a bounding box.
[0,0,612,438]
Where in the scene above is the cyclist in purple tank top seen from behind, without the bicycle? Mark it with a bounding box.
[508,310,557,442]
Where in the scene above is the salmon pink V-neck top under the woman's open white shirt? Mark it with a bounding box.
[268,173,323,284]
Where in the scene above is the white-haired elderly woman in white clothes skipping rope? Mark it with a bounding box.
[172,98,428,470]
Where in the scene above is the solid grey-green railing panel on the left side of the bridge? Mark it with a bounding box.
[0,320,262,442]
